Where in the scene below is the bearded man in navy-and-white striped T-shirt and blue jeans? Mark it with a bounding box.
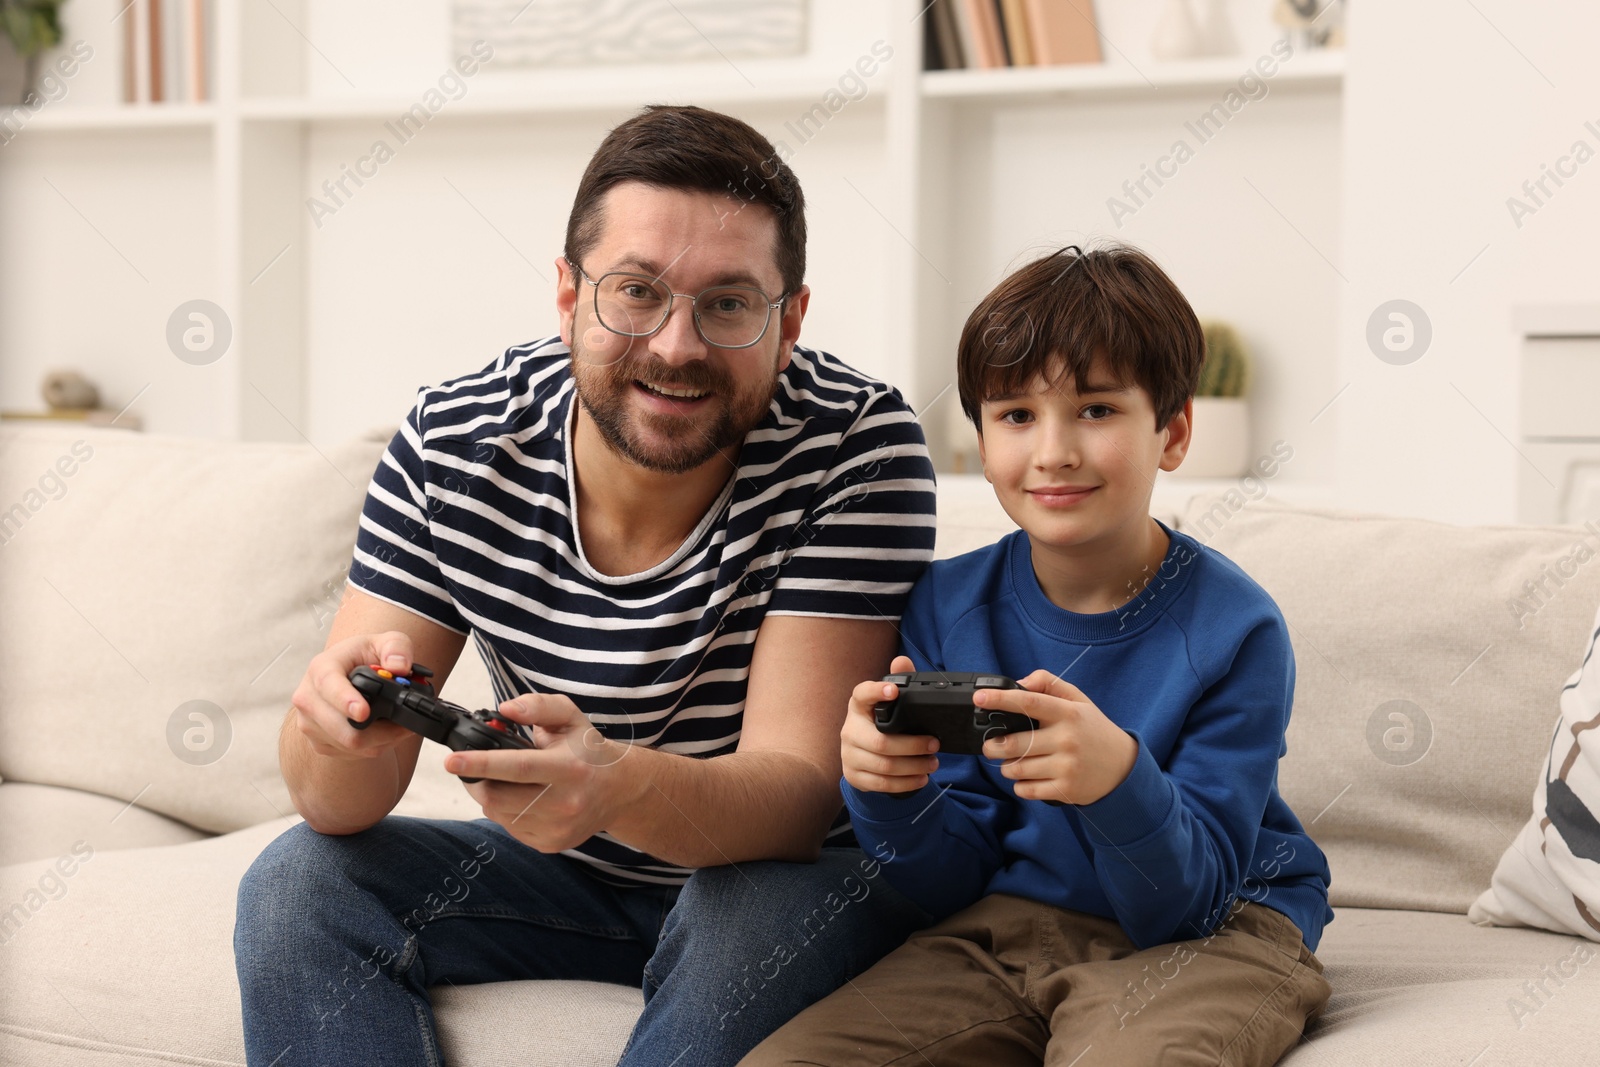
[235,107,933,1067]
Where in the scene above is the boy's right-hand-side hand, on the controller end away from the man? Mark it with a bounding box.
[972,670,1139,805]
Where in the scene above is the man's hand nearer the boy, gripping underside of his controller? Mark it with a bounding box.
[445,693,648,853]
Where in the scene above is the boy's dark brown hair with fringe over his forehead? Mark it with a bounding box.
[955,245,1205,432]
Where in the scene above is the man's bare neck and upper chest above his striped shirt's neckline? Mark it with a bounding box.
[573,398,738,576]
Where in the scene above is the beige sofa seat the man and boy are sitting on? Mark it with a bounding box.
[0,819,1600,1067]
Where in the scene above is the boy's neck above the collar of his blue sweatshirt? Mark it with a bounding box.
[1029,515,1171,614]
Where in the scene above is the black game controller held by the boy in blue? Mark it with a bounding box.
[872,670,1061,808]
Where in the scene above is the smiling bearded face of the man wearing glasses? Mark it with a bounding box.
[557,182,810,474]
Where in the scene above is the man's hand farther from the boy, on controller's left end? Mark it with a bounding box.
[293,630,416,760]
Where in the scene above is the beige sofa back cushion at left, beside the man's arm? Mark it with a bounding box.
[0,426,384,832]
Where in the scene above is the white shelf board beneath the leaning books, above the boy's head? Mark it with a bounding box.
[922,51,1344,102]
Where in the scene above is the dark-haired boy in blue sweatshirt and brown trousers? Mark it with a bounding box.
[744,246,1333,1067]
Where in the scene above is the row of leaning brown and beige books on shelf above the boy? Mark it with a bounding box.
[923,0,1101,70]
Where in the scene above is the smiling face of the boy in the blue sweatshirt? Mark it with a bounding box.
[978,360,1194,549]
